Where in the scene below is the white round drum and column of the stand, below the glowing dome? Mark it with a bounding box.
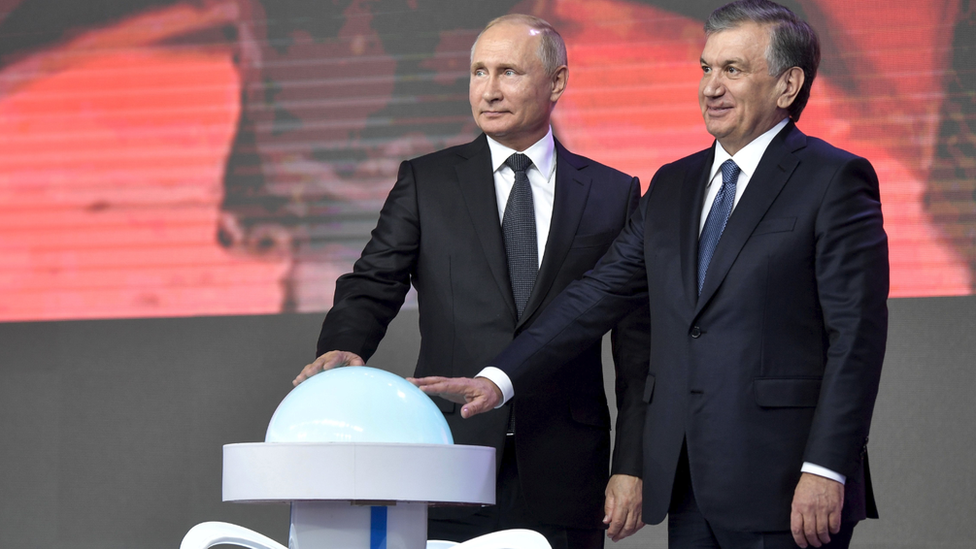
[222,442,495,549]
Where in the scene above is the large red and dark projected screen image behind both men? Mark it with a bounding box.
[0,0,976,321]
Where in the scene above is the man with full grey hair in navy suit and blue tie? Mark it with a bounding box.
[414,0,888,548]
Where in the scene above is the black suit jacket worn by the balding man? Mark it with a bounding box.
[318,135,647,528]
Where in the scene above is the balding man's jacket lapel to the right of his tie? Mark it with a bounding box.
[519,141,592,325]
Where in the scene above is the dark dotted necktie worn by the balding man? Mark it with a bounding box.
[502,153,539,318]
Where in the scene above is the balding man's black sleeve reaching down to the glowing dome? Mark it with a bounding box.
[317,161,420,360]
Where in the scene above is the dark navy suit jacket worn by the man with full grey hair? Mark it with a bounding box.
[492,123,888,531]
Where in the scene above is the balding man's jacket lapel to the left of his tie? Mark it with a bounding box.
[455,134,517,316]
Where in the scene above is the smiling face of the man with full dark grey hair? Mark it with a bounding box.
[698,23,792,154]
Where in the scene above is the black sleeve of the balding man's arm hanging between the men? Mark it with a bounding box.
[610,178,650,477]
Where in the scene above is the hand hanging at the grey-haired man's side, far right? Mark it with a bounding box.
[790,473,844,549]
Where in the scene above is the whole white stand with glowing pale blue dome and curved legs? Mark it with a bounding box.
[180,366,551,549]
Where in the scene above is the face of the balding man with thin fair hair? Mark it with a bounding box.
[468,23,566,151]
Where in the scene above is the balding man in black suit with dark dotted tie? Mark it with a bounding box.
[295,11,648,549]
